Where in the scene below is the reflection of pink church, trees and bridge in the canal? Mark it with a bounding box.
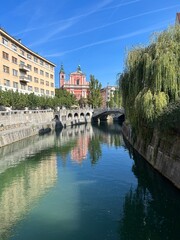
[56,122,124,164]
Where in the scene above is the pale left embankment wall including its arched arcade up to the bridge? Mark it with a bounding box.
[0,109,93,147]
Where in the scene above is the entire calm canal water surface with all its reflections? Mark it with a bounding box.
[0,123,180,240]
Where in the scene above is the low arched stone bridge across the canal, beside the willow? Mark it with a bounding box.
[92,108,125,121]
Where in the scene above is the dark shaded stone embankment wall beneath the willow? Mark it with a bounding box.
[122,124,180,189]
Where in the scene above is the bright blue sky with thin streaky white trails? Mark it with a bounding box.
[0,0,180,87]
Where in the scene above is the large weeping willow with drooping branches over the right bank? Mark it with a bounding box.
[119,26,180,131]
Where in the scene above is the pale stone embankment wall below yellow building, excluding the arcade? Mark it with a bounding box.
[0,110,55,147]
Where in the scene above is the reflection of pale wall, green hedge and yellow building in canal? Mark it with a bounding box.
[0,136,57,239]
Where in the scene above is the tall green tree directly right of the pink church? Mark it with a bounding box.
[88,75,102,108]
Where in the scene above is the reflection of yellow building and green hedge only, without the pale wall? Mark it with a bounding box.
[0,154,57,239]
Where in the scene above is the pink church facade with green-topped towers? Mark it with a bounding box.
[59,65,89,100]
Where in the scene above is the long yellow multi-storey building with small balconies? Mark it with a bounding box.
[0,28,55,97]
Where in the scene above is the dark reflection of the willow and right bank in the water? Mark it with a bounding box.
[118,141,180,240]
